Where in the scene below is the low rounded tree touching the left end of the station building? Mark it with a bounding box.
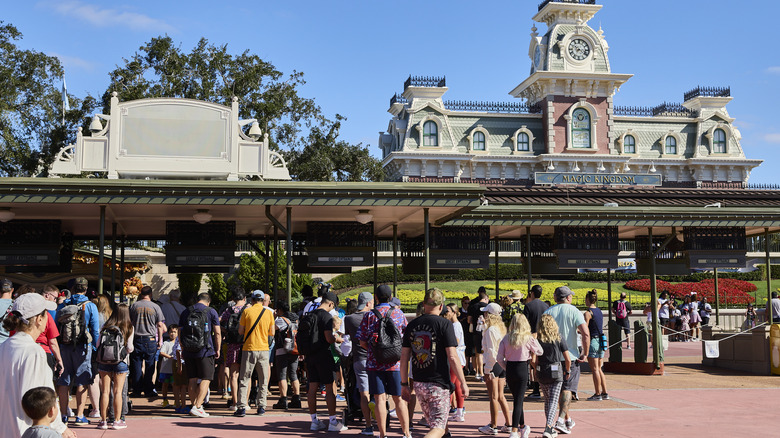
[285,114,384,181]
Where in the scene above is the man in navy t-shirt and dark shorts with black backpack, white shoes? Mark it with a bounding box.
[177,292,222,418]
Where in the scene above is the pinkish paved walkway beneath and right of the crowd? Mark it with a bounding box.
[68,342,780,438]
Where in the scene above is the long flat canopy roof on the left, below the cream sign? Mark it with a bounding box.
[0,178,484,239]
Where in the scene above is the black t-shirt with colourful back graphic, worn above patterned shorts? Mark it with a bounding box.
[402,315,458,389]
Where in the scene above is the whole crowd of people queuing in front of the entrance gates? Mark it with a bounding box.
[0,278,776,438]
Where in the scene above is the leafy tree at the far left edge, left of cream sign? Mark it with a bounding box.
[0,21,97,176]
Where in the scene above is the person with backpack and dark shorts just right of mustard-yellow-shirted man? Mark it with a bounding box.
[273,301,301,410]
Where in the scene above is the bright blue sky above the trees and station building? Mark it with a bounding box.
[6,0,780,183]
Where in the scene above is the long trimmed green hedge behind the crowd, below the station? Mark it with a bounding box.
[331,264,524,289]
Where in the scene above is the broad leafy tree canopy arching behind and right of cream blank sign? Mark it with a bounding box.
[103,36,383,181]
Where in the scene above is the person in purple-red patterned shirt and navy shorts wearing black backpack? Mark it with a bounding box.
[357,284,411,437]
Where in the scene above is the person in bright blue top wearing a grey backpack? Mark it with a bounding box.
[55,277,100,426]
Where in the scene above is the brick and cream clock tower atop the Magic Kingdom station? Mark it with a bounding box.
[509,0,632,157]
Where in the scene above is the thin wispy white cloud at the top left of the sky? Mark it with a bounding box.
[44,1,176,32]
